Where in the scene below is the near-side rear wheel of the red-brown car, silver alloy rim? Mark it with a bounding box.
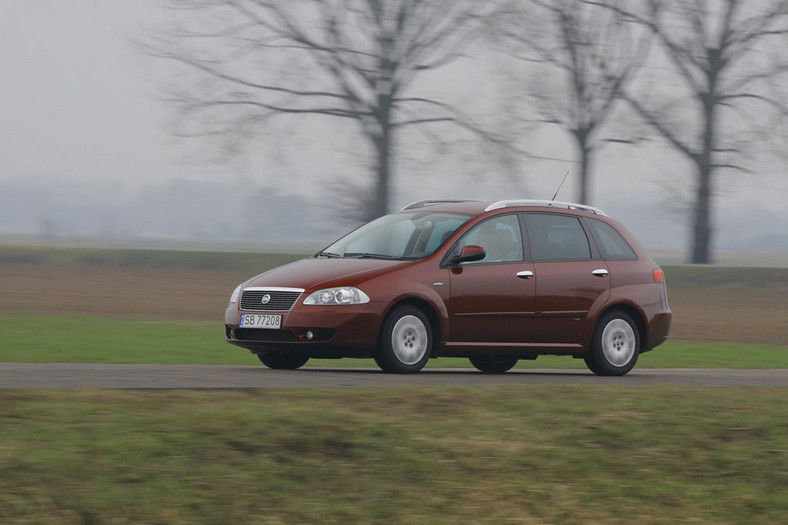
[585,310,640,376]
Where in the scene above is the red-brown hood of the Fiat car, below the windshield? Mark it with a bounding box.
[244,258,409,291]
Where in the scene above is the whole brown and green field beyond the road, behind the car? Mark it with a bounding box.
[0,246,788,362]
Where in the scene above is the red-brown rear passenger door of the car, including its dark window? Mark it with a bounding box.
[526,213,610,345]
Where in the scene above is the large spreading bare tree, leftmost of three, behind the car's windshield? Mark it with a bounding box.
[145,0,498,219]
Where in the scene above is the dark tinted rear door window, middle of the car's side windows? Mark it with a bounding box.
[528,213,591,261]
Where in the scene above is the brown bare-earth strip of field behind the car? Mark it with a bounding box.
[0,263,788,345]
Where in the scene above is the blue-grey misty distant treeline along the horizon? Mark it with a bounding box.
[0,174,788,253]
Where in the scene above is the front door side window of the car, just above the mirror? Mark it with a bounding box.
[455,214,523,265]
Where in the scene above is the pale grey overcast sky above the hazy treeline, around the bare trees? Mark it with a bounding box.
[0,0,788,254]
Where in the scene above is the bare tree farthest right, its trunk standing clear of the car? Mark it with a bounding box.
[616,0,788,263]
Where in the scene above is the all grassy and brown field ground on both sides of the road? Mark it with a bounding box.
[0,247,788,525]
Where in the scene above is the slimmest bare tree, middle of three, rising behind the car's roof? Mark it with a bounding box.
[499,0,649,203]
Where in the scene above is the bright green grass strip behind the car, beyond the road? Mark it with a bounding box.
[0,315,788,368]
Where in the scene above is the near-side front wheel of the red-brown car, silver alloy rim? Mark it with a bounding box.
[375,306,432,374]
